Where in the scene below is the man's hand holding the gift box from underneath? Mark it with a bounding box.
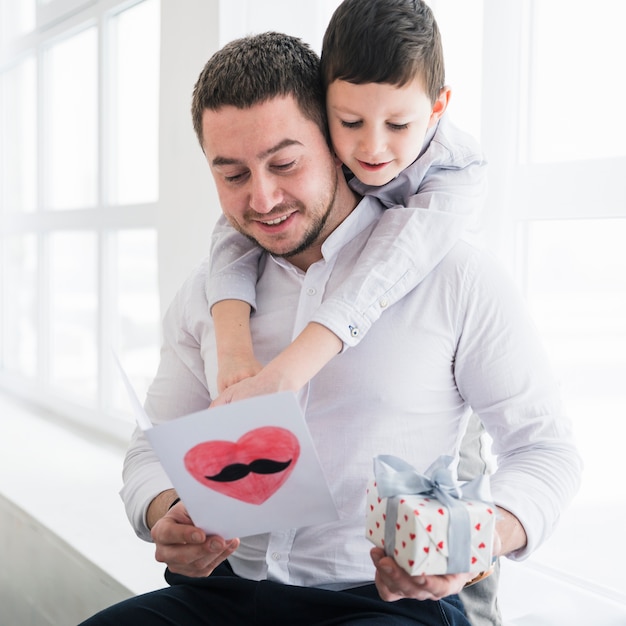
[370,548,473,602]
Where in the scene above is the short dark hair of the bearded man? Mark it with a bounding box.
[191,32,329,147]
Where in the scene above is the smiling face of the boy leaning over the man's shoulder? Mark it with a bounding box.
[326,79,450,186]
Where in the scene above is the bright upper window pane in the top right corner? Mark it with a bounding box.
[530,0,626,162]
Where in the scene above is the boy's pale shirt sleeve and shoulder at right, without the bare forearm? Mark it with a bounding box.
[312,120,486,347]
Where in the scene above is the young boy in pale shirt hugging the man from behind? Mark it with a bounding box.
[207,0,486,404]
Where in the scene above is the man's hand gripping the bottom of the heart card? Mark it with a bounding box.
[150,502,239,578]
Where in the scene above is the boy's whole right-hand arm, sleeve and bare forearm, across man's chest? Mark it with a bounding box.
[214,120,486,405]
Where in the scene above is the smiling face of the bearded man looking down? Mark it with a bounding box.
[202,96,343,265]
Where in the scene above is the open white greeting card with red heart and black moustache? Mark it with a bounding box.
[120,356,338,539]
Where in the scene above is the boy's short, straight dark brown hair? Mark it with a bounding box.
[321,0,445,103]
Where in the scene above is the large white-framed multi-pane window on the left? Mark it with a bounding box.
[0,0,160,432]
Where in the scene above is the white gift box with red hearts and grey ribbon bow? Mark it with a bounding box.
[365,455,496,576]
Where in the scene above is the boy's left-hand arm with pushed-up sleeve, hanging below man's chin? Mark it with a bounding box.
[206,215,261,392]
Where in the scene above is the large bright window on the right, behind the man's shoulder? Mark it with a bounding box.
[482,0,626,593]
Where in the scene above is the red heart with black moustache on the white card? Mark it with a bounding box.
[184,426,300,504]
